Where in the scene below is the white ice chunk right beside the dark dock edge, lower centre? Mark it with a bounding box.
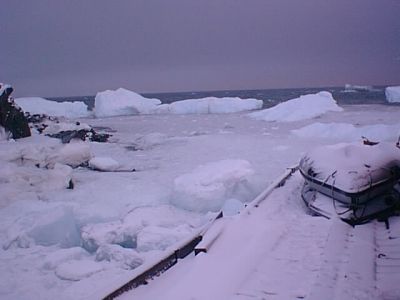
[136,225,190,252]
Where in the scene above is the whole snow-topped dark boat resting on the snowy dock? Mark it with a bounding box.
[299,143,400,225]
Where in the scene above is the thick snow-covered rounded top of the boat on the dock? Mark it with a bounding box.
[300,143,400,193]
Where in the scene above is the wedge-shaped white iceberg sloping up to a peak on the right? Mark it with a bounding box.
[249,92,343,122]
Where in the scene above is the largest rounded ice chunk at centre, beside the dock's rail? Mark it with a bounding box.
[171,159,254,212]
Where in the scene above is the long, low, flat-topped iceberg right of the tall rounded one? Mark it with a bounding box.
[157,97,263,114]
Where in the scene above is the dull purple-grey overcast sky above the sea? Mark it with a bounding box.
[0,0,400,96]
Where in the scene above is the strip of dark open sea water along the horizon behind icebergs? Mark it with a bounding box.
[48,86,393,109]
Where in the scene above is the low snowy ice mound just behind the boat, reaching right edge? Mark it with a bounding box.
[292,123,400,142]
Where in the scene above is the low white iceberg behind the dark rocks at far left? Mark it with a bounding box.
[15,97,91,118]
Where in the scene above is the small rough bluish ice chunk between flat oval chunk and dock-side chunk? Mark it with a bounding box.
[96,245,143,270]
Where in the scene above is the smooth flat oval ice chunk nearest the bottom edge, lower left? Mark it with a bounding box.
[55,260,103,281]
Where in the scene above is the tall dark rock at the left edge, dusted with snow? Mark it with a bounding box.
[0,84,31,139]
